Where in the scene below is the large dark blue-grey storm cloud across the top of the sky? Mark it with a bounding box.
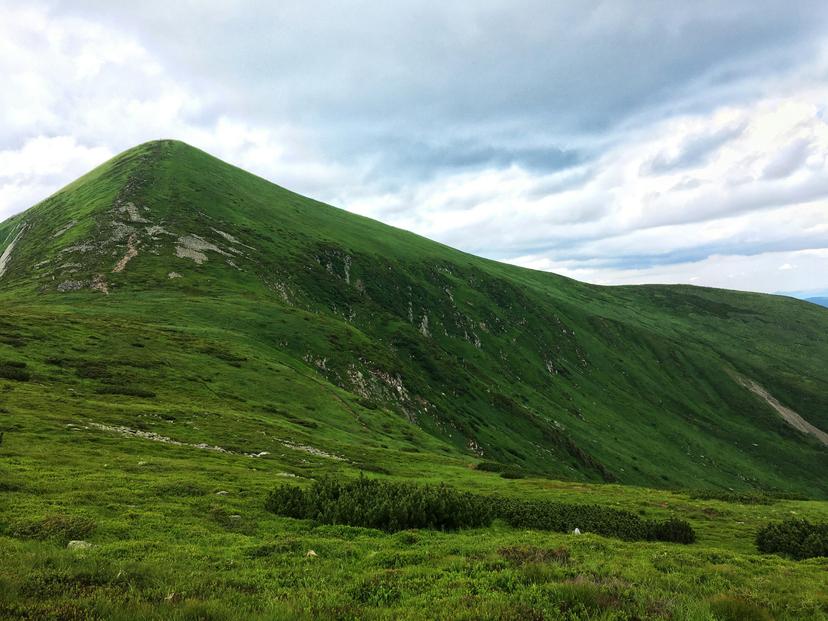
[53,0,828,153]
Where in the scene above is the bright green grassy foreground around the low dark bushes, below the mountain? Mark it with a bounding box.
[0,400,828,620]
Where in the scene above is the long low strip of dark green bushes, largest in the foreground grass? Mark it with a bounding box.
[266,476,696,543]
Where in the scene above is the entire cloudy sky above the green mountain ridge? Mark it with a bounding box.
[0,0,828,294]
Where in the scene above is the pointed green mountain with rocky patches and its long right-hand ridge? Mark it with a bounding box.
[0,141,828,497]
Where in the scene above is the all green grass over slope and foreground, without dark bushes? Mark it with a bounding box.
[0,141,828,620]
